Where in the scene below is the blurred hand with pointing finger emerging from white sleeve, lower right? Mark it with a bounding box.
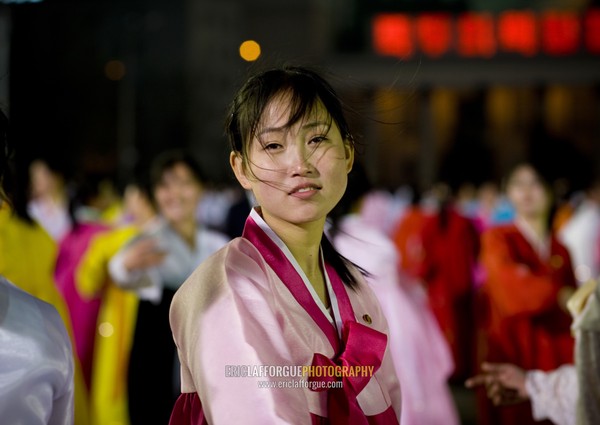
[465,363,529,405]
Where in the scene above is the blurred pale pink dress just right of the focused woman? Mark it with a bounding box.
[334,216,459,425]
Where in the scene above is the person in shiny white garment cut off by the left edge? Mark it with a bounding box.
[0,107,74,425]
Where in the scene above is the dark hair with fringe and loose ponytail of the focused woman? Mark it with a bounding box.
[225,66,360,288]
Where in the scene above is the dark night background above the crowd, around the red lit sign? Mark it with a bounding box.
[0,0,600,191]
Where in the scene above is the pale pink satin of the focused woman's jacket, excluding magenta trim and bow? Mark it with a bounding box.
[171,220,401,425]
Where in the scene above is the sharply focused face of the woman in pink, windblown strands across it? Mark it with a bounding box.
[231,95,354,229]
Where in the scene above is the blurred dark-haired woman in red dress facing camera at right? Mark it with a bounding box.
[479,164,575,425]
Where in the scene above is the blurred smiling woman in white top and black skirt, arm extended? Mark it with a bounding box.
[108,151,228,425]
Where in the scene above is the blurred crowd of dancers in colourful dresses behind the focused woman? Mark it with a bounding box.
[0,142,600,425]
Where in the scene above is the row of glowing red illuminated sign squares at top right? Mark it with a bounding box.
[372,9,600,58]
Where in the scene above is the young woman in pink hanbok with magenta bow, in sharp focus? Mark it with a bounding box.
[170,67,401,425]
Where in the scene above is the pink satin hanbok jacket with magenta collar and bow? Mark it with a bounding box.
[171,210,401,425]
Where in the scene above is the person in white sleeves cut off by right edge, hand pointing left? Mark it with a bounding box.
[466,280,600,425]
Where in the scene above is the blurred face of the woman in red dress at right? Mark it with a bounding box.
[506,165,550,218]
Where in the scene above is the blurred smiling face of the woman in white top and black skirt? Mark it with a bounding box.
[154,164,202,223]
